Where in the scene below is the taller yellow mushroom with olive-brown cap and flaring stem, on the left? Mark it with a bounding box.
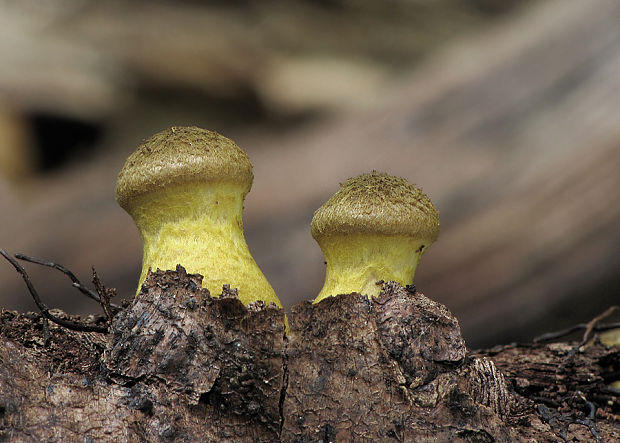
[116,127,282,306]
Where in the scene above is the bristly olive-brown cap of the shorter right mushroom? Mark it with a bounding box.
[311,171,439,243]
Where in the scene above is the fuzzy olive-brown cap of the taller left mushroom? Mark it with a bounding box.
[116,126,254,209]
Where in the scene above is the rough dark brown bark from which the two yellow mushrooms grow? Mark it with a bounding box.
[0,267,620,442]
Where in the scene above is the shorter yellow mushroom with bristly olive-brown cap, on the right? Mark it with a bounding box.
[311,172,439,303]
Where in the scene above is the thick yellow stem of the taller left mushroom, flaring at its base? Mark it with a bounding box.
[127,183,281,306]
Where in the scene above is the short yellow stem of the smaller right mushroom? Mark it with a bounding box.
[314,234,426,303]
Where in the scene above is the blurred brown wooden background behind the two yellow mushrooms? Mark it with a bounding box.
[0,0,620,347]
